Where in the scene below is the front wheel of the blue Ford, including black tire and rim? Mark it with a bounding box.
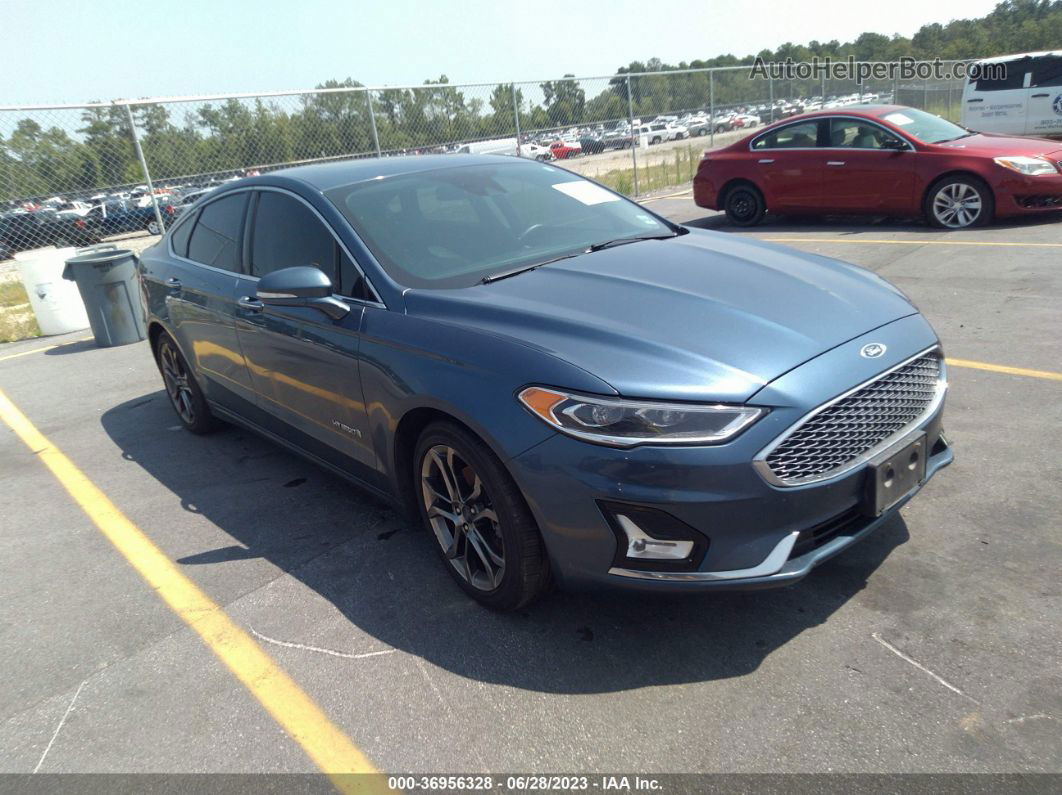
[410,421,549,610]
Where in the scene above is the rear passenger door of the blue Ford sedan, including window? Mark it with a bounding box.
[163,191,255,414]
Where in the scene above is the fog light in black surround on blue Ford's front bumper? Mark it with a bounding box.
[598,501,708,571]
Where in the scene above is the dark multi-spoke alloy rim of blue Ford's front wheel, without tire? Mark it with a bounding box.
[421,445,506,591]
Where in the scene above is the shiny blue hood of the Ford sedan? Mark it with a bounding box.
[406,230,918,401]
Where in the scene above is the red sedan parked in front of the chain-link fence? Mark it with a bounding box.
[693,105,1062,229]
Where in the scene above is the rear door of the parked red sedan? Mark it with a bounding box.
[750,119,826,211]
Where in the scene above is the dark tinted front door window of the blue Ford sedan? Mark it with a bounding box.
[251,191,339,284]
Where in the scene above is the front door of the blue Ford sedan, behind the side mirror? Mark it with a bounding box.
[237,189,376,479]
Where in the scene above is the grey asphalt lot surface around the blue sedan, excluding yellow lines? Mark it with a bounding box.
[0,195,1062,773]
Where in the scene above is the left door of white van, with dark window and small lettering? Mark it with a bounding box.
[962,56,1030,135]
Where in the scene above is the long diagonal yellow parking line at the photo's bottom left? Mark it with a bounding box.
[0,390,386,792]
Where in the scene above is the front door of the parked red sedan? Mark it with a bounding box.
[821,117,919,213]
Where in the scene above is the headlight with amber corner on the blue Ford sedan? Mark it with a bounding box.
[518,386,767,447]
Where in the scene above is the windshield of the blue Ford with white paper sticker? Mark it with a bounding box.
[326,158,674,288]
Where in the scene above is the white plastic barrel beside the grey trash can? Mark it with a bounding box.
[15,246,89,336]
